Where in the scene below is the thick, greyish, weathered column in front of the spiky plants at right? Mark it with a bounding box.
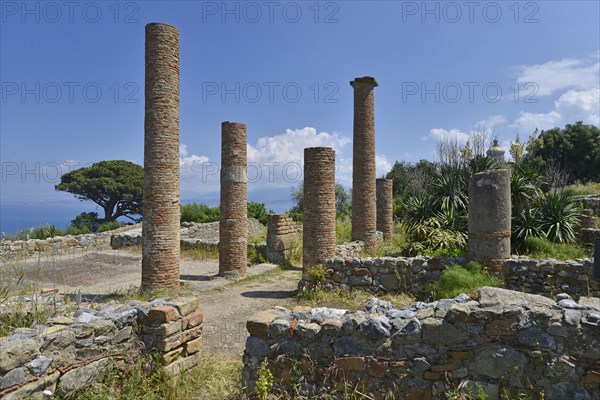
[469,169,511,274]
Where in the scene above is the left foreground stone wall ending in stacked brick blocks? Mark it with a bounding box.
[0,296,204,400]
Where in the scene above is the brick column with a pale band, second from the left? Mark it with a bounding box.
[219,122,248,277]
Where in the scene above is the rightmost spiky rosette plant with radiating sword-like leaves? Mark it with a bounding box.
[537,193,580,243]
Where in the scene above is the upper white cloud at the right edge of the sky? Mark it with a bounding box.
[515,52,600,96]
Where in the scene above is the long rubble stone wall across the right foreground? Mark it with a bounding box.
[242,287,600,400]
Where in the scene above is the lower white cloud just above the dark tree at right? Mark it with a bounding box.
[510,87,600,134]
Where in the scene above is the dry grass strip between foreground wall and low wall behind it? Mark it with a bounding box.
[295,288,415,310]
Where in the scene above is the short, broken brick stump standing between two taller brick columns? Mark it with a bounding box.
[266,214,298,264]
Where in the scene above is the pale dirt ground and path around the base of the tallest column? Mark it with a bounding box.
[0,250,301,360]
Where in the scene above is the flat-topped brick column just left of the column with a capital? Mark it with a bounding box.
[302,147,335,281]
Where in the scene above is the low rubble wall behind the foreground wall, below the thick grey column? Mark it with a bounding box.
[324,257,600,298]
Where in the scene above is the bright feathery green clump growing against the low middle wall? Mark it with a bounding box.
[426,262,502,300]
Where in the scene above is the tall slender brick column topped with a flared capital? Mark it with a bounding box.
[350,76,378,251]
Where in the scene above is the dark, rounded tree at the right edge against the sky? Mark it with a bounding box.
[523,121,600,183]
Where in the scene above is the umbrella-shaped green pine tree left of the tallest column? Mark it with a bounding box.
[55,160,144,221]
